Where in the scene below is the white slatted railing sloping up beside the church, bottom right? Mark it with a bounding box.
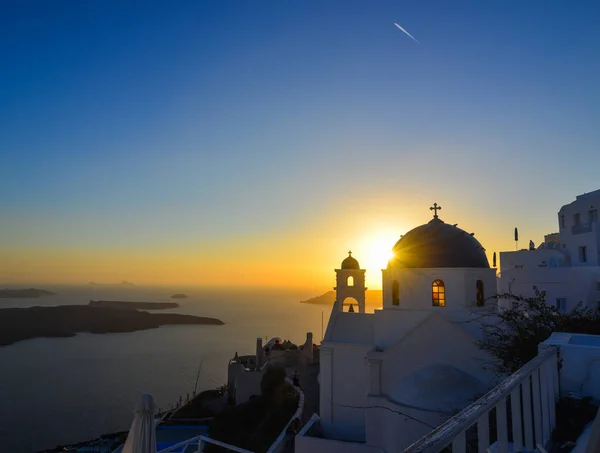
[403,346,558,453]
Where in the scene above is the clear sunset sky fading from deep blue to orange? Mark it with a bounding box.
[0,0,600,291]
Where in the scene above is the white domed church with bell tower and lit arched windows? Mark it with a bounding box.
[319,204,497,451]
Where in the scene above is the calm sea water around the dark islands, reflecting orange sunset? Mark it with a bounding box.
[0,285,330,453]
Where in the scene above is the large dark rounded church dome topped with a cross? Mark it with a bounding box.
[388,215,490,268]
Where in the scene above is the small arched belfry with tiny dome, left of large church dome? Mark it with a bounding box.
[333,252,367,313]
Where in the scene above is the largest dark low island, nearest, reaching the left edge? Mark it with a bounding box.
[0,305,224,346]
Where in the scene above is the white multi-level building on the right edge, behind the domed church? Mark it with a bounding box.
[498,190,600,312]
